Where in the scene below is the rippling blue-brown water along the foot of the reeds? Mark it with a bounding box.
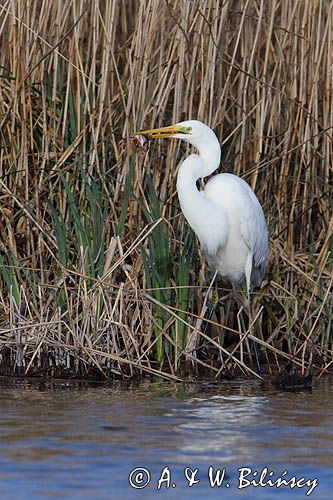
[0,380,333,500]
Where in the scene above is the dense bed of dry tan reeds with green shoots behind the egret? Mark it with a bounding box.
[0,0,333,380]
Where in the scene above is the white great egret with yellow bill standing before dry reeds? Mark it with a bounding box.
[135,120,268,360]
